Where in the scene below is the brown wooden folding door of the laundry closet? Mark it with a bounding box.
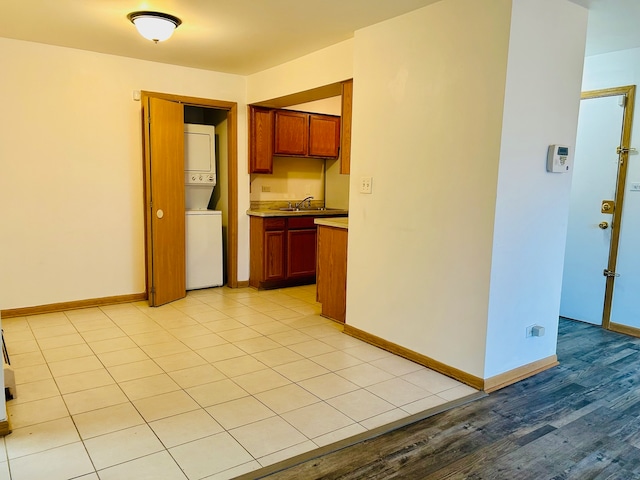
[144,97,186,306]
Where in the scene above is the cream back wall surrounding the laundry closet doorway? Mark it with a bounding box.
[0,38,249,309]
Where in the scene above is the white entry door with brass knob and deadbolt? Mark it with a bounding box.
[560,87,633,328]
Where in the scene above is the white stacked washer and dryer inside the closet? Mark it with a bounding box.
[184,124,223,290]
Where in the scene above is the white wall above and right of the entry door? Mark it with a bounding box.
[582,48,640,328]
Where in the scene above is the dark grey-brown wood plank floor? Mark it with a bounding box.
[255,319,640,480]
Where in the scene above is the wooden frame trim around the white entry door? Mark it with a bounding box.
[580,85,636,330]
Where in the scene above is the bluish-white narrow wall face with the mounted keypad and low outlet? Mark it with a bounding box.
[484,0,587,378]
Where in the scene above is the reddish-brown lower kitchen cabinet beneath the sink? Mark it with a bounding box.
[249,216,316,289]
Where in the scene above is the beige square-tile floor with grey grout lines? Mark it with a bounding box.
[0,285,476,480]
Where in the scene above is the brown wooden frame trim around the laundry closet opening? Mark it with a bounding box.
[140,90,238,298]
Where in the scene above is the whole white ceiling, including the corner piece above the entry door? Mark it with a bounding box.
[0,0,640,75]
